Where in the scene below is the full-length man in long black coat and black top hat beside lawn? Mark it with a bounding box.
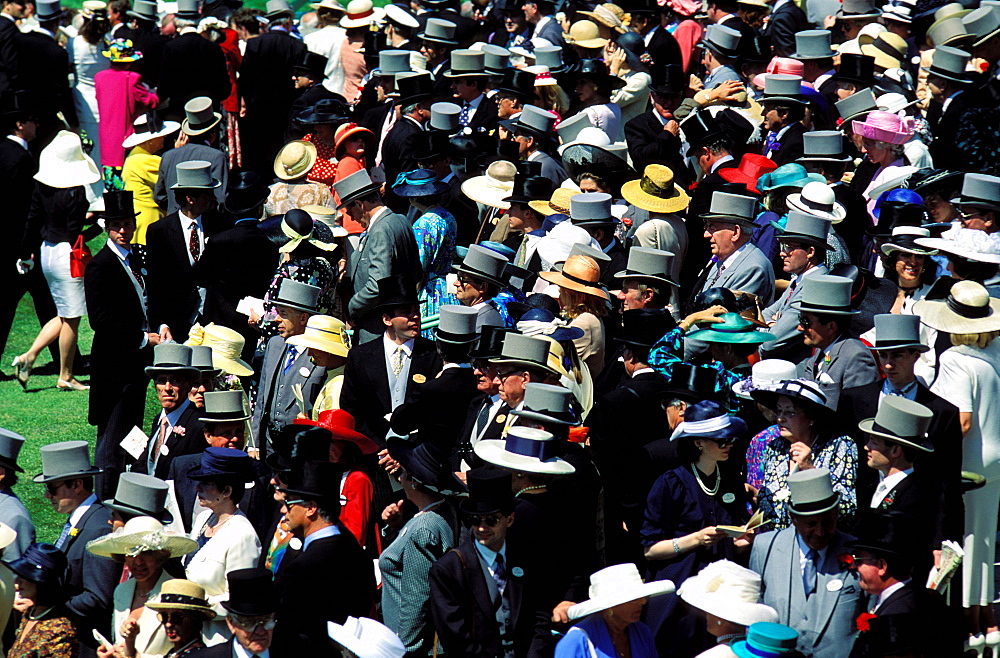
[83,190,160,500]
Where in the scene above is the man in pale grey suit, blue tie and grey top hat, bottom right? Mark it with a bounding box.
[750,468,861,658]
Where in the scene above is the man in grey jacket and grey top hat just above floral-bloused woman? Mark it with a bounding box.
[792,274,878,409]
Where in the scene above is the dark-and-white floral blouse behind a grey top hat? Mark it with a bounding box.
[757,430,858,530]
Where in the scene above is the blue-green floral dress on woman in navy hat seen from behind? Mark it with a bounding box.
[413,206,458,339]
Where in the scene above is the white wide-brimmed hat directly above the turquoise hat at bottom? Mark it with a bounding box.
[677,560,778,626]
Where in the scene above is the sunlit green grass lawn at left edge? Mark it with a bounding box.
[0,235,156,541]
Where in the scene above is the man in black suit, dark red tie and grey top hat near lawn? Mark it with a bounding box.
[146,160,222,342]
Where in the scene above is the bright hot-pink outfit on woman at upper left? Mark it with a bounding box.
[94,64,160,168]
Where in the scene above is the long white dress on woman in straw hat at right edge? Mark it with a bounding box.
[931,340,1000,607]
